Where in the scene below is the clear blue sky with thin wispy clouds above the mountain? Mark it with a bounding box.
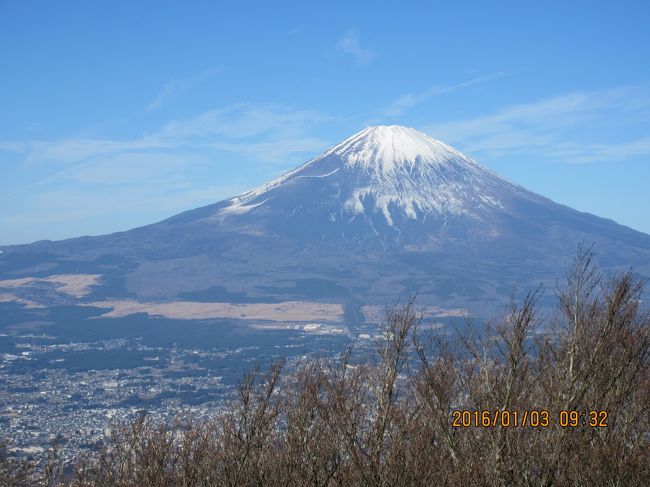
[0,0,650,244]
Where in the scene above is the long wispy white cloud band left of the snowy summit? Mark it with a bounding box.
[0,104,328,200]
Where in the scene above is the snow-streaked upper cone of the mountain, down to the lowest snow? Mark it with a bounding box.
[219,125,512,228]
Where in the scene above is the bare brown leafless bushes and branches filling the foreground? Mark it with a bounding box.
[0,248,650,486]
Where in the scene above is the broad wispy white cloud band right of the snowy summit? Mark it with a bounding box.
[423,86,650,163]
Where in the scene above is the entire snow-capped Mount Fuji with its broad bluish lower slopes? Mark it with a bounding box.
[0,126,650,321]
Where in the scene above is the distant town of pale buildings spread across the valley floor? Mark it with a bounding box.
[0,323,381,464]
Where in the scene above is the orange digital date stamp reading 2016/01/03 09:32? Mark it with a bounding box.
[451,409,608,428]
